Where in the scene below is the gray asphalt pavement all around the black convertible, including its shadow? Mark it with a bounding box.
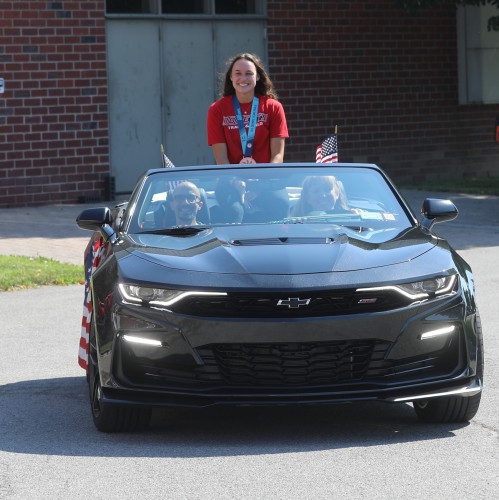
[0,191,499,500]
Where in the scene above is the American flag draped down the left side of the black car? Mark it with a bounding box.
[78,237,105,370]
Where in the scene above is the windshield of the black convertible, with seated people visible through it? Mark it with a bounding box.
[127,164,413,236]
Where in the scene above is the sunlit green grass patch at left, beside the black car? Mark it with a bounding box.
[0,255,85,292]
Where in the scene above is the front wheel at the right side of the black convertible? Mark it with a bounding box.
[413,311,484,423]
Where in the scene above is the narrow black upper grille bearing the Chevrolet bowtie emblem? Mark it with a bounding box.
[173,289,410,318]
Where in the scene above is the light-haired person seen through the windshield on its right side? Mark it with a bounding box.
[292,175,353,216]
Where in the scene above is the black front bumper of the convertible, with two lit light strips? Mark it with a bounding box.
[94,294,481,407]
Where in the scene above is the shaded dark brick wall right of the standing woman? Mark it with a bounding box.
[268,0,499,184]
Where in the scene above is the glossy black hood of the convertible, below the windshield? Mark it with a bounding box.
[120,224,438,275]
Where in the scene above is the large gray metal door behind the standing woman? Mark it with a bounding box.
[107,19,267,194]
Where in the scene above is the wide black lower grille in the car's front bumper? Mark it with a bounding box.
[125,338,464,392]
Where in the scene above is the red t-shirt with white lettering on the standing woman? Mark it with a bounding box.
[207,96,289,163]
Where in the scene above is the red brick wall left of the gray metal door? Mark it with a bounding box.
[0,0,109,207]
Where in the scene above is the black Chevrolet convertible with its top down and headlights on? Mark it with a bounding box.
[77,163,483,432]
